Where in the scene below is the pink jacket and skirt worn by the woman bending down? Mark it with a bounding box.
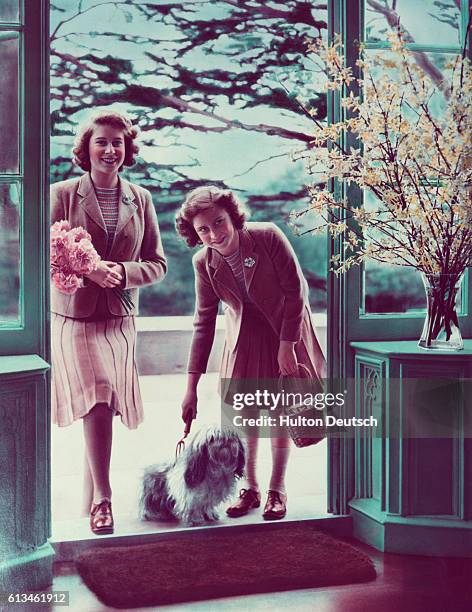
[188,222,325,388]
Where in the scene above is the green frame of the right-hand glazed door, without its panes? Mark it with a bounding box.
[327,0,472,514]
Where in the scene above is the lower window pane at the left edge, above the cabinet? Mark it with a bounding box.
[0,183,20,325]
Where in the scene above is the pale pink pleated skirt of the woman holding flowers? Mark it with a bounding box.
[51,313,144,429]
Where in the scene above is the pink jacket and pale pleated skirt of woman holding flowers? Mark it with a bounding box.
[51,174,167,429]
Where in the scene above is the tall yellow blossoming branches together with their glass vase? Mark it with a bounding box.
[300,21,472,350]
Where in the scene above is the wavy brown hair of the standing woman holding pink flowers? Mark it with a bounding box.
[72,111,139,172]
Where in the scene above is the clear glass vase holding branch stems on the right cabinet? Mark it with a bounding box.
[418,272,464,351]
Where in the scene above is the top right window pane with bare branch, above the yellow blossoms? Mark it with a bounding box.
[365,0,461,46]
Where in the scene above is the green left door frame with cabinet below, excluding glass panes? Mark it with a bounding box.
[0,0,54,592]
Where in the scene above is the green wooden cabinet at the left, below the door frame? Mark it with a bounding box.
[0,355,54,591]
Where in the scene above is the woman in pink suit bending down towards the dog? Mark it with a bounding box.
[176,186,325,520]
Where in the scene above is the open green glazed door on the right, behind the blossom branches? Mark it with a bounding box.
[327,0,472,514]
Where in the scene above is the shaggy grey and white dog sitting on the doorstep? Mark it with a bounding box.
[140,427,245,525]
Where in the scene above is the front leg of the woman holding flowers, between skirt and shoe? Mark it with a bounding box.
[83,404,113,503]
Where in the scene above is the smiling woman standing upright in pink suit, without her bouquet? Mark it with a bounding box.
[51,112,167,534]
